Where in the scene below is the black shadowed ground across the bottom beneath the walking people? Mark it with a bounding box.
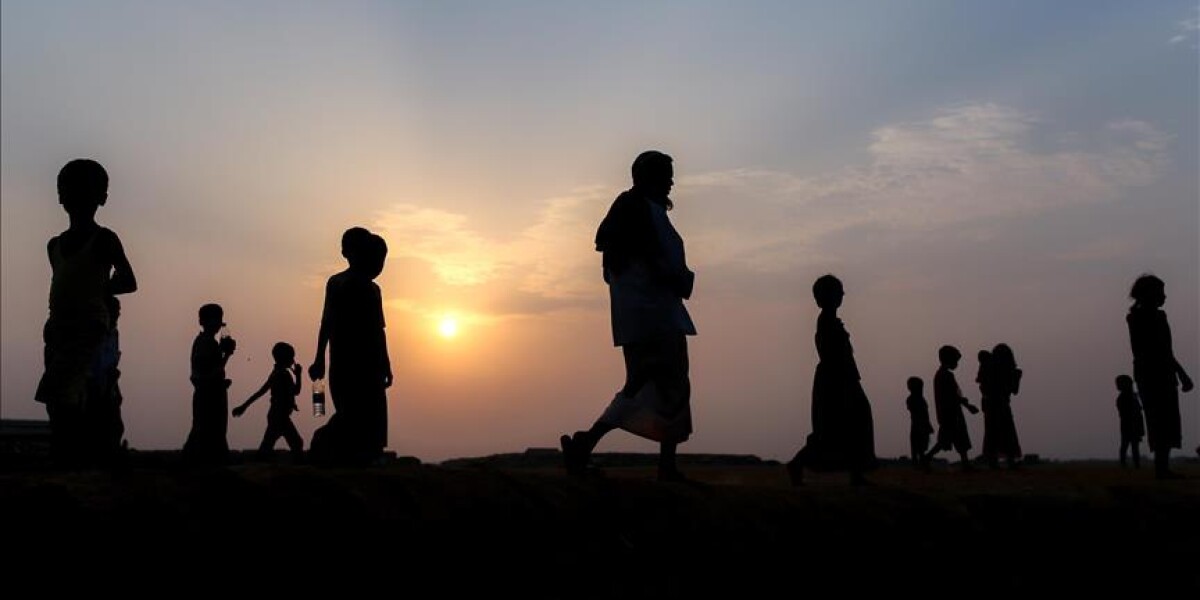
[0,453,1200,598]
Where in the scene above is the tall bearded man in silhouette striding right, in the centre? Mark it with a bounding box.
[559,150,696,481]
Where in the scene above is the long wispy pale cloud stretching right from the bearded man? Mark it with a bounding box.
[679,103,1171,270]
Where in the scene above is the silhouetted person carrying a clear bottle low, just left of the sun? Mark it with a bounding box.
[308,227,392,464]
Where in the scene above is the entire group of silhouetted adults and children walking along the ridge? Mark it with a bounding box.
[35,150,1193,485]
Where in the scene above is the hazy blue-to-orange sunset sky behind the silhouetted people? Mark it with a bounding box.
[0,0,1200,461]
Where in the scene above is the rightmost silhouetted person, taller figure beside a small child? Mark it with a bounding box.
[1126,275,1192,479]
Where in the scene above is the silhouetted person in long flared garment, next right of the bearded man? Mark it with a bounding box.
[787,275,875,485]
